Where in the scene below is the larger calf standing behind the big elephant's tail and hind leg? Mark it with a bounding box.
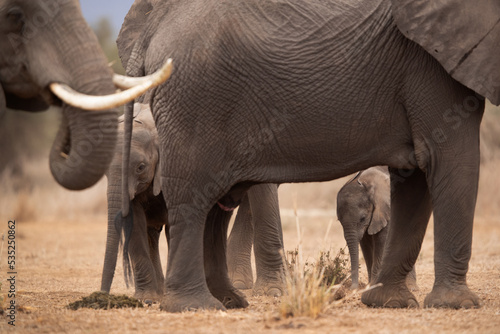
[101,104,168,300]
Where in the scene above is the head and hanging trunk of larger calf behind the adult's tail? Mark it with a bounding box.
[101,103,161,292]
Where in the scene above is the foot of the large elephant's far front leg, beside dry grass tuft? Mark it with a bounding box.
[361,284,419,308]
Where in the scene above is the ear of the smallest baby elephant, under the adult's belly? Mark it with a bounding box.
[358,167,391,235]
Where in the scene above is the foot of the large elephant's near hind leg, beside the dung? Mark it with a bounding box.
[160,291,226,313]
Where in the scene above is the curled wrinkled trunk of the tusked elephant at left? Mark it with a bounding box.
[40,2,118,190]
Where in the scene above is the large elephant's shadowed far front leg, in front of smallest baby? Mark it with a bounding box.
[361,169,432,308]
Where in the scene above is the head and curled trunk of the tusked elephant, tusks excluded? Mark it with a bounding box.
[0,0,117,190]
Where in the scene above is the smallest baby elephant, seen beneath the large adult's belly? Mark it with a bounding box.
[337,166,418,290]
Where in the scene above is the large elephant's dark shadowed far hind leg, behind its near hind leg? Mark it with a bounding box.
[204,205,248,308]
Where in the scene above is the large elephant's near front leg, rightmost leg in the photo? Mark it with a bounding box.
[424,146,480,309]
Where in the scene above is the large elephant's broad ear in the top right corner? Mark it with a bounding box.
[392,0,500,105]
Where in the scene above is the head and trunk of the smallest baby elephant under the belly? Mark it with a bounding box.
[337,167,391,288]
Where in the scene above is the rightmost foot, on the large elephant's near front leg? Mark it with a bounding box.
[424,284,481,309]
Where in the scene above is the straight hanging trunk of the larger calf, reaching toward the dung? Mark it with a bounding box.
[101,180,121,293]
